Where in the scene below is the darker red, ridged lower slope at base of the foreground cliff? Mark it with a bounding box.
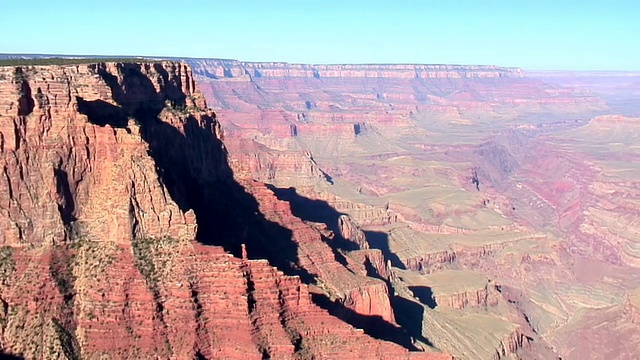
[1,239,447,359]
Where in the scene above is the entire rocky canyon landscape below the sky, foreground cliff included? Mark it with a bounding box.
[0,56,640,360]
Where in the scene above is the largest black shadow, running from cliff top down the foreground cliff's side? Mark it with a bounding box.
[93,63,314,283]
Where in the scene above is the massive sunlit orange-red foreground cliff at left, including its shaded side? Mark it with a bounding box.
[0,62,447,359]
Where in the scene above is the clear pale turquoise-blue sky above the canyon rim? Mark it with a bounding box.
[0,0,640,70]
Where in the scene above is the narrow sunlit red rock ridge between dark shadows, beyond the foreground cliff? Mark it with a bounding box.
[242,180,399,326]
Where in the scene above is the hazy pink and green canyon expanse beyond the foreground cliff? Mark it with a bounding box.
[187,59,640,359]
